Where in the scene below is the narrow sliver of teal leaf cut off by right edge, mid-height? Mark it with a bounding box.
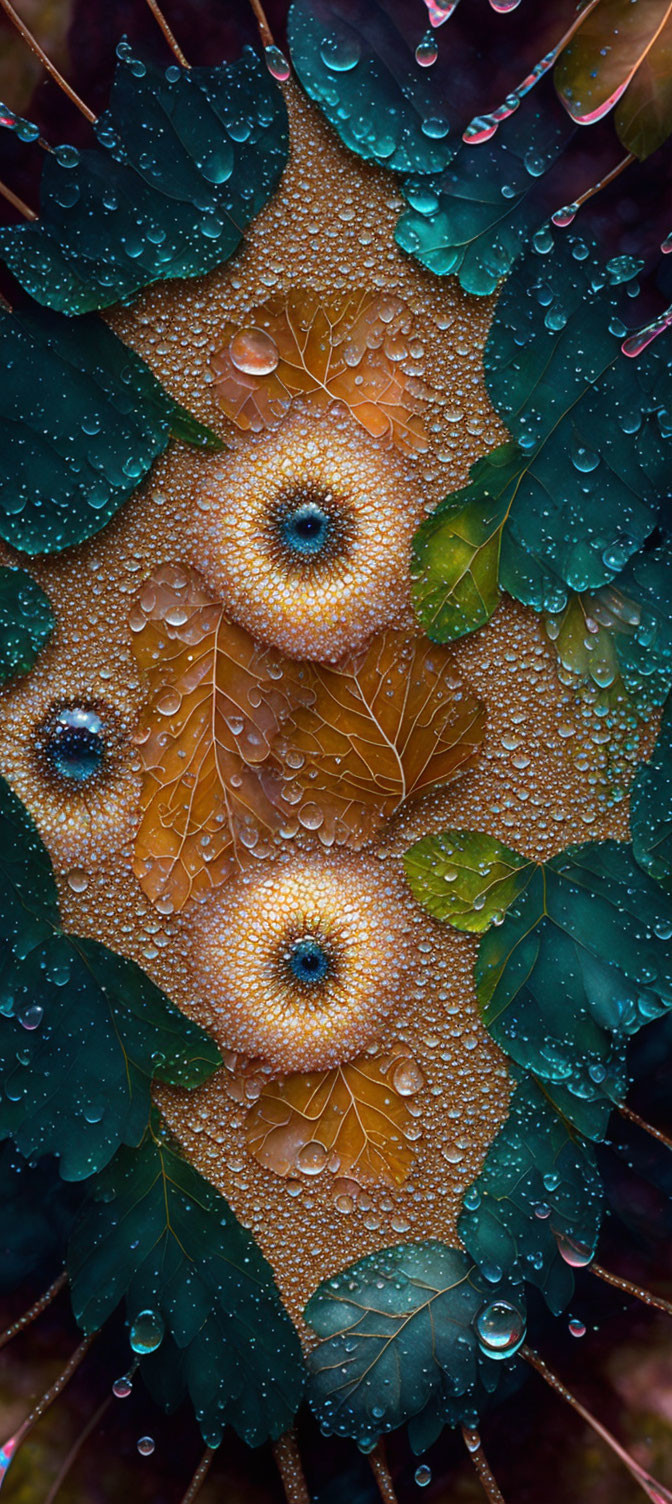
[630,702,672,895]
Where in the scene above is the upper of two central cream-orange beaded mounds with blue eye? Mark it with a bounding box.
[192,418,422,662]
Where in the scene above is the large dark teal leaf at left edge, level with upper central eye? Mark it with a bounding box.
[0,308,213,553]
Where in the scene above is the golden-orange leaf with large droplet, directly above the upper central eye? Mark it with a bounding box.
[212,287,427,454]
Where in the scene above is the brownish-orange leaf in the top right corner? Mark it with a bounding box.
[555,0,672,125]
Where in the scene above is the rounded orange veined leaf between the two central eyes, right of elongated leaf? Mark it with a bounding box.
[278,629,486,844]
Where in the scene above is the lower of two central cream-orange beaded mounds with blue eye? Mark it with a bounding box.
[191,854,413,1072]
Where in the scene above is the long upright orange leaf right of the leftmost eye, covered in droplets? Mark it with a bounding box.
[131,566,294,910]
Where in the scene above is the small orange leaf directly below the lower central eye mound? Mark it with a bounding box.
[247,1054,422,1185]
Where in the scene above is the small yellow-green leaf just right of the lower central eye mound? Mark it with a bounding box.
[404,830,535,934]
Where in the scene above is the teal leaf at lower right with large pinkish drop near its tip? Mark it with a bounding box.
[457,1078,603,1316]
